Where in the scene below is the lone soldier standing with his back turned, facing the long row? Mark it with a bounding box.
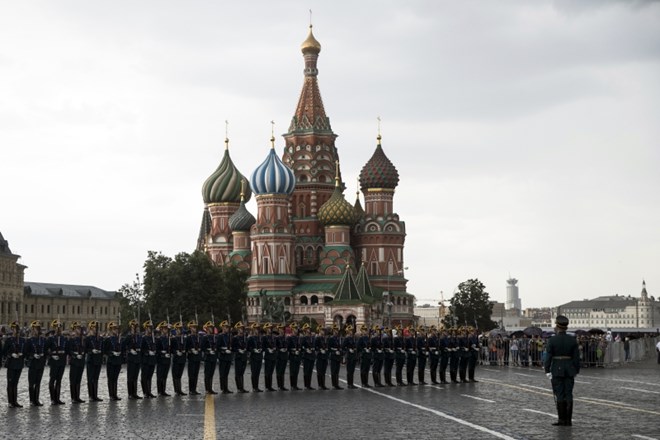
[543,315,580,426]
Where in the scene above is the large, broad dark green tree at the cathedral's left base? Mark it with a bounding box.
[130,251,248,325]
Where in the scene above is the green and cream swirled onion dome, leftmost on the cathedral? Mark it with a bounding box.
[202,139,252,203]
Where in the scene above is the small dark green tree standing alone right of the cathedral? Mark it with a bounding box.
[443,279,497,331]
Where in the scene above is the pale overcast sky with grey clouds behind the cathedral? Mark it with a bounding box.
[0,0,660,308]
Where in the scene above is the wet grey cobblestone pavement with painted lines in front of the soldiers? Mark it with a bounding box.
[0,361,660,440]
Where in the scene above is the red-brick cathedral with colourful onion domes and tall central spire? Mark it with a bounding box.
[198,25,414,325]
